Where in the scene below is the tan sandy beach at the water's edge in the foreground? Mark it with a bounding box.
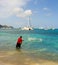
[0,51,58,65]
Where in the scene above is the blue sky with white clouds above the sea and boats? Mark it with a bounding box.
[0,0,58,28]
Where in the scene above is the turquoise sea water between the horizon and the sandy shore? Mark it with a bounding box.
[0,29,58,60]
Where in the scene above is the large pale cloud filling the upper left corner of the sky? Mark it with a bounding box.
[0,0,29,18]
